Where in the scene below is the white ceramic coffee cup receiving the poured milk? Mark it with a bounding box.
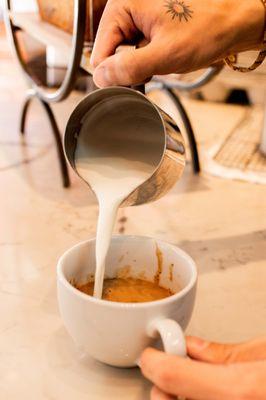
[57,236,197,367]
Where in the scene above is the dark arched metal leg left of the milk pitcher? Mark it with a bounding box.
[20,92,70,188]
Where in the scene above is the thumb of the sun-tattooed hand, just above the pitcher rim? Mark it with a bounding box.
[93,43,160,87]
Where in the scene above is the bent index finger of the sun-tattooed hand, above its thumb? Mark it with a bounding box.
[90,2,137,68]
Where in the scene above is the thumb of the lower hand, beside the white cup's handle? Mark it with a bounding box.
[187,337,266,364]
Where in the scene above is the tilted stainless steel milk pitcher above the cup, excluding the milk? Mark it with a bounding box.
[64,87,185,206]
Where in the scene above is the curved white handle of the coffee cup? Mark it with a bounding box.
[148,319,187,357]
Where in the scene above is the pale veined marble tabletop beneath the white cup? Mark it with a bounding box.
[0,25,266,400]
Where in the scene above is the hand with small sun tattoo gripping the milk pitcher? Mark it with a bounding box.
[91,0,264,87]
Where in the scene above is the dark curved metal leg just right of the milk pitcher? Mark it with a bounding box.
[164,87,201,174]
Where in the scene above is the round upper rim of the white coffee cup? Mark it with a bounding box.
[57,235,198,310]
